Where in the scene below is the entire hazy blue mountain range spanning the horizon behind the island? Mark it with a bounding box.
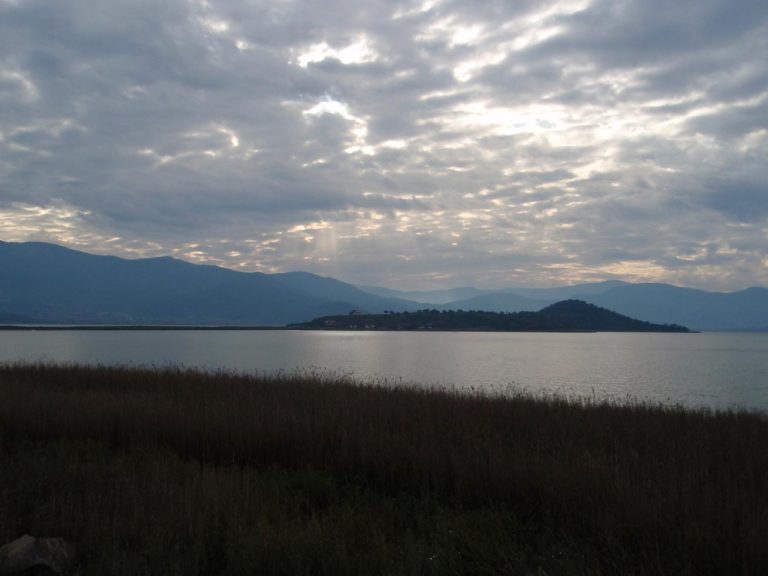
[0,241,768,330]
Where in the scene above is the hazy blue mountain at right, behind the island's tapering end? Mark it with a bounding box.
[583,284,768,330]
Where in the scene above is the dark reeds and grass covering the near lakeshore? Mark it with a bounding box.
[0,365,768,575]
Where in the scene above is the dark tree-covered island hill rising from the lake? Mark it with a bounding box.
[293,300,689,332]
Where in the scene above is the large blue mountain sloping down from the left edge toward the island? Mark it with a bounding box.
[0,242,416,325]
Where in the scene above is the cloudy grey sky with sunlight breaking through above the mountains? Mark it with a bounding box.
[0,0,768,290]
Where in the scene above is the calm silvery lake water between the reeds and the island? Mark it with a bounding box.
[0,330,768,410]
